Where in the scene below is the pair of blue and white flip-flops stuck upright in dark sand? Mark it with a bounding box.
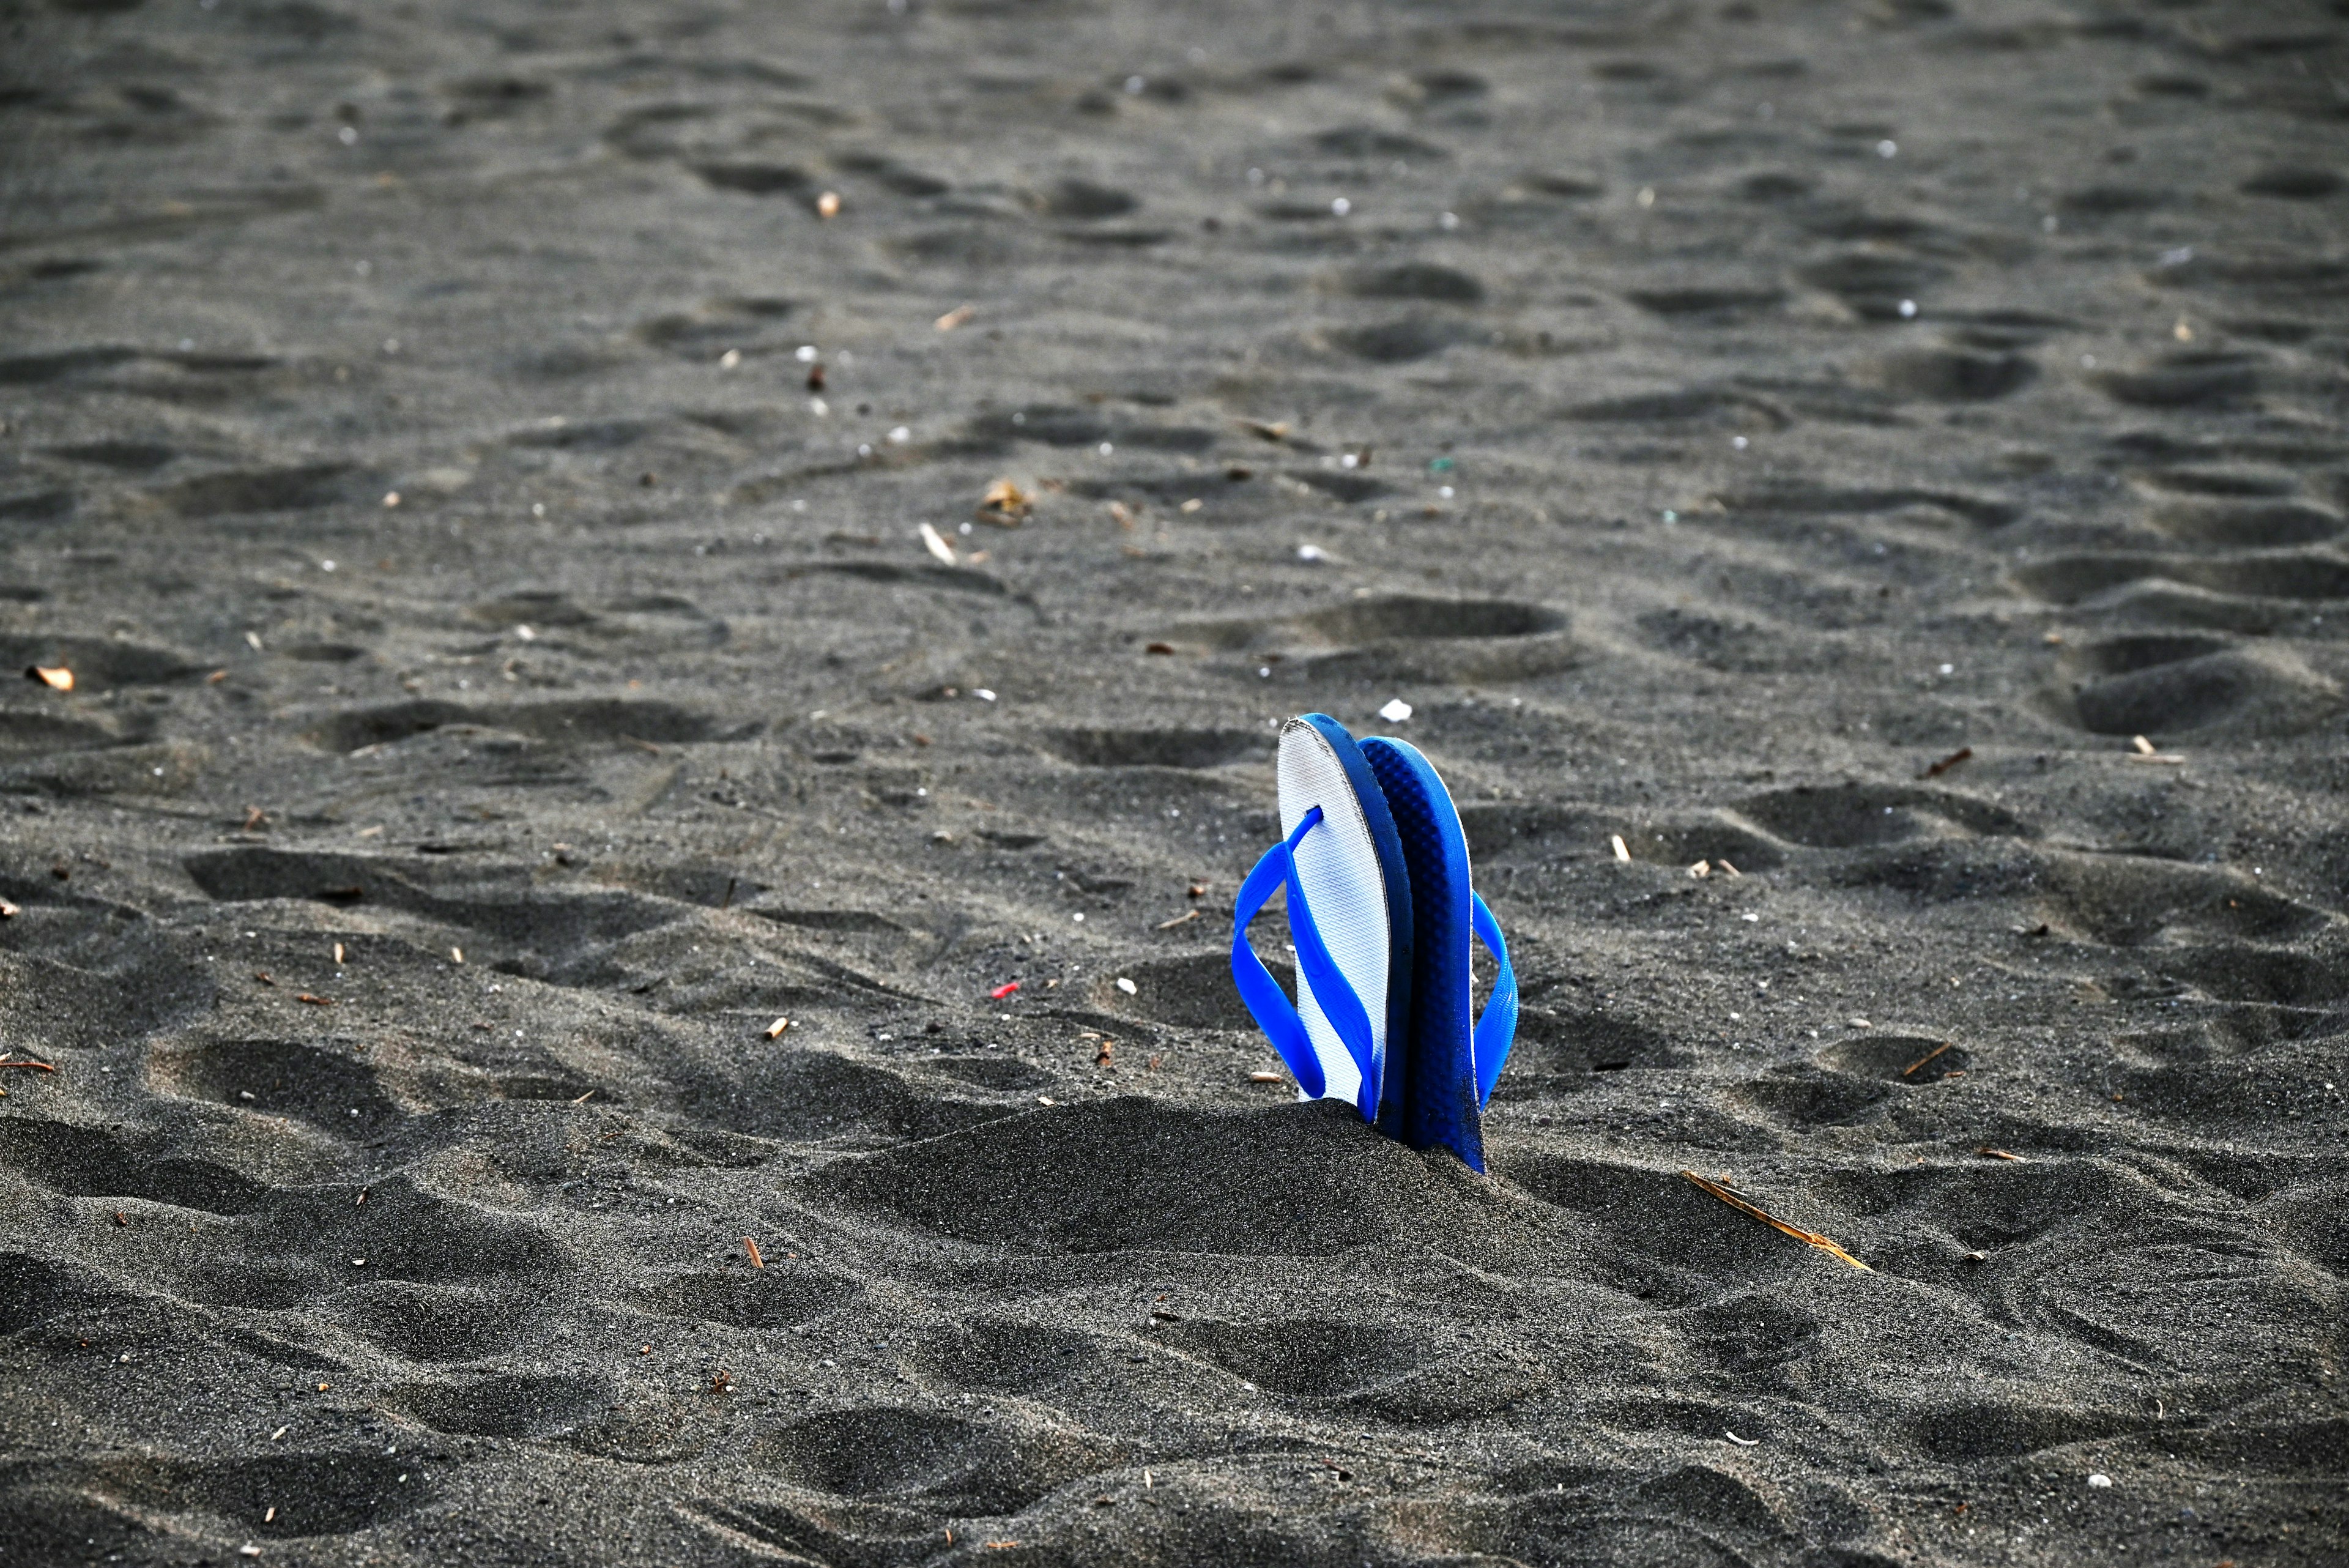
[1231,712,1518,1171]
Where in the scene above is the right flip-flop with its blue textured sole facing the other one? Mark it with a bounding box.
[1362,736,1518,1171]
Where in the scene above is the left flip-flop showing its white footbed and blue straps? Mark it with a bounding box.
[1231,712,1414,1138]
